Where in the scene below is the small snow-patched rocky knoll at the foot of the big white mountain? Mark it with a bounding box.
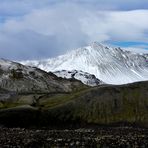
[53,70,103,86]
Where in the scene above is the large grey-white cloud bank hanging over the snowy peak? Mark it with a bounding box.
[0,3,148,58]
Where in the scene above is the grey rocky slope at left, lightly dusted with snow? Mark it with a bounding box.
[0,59,86,93]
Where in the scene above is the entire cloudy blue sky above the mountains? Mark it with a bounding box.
[0,0,148,60]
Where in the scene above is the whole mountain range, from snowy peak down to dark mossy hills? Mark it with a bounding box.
[0,43,148,127]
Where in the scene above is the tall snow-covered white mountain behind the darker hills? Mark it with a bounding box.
[22,42,148,84]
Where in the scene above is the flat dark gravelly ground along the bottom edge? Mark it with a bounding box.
[0,127,148,148]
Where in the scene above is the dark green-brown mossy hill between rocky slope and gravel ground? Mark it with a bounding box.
[0,78,148,127]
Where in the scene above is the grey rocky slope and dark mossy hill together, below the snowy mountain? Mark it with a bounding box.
[0,57,148,127]
